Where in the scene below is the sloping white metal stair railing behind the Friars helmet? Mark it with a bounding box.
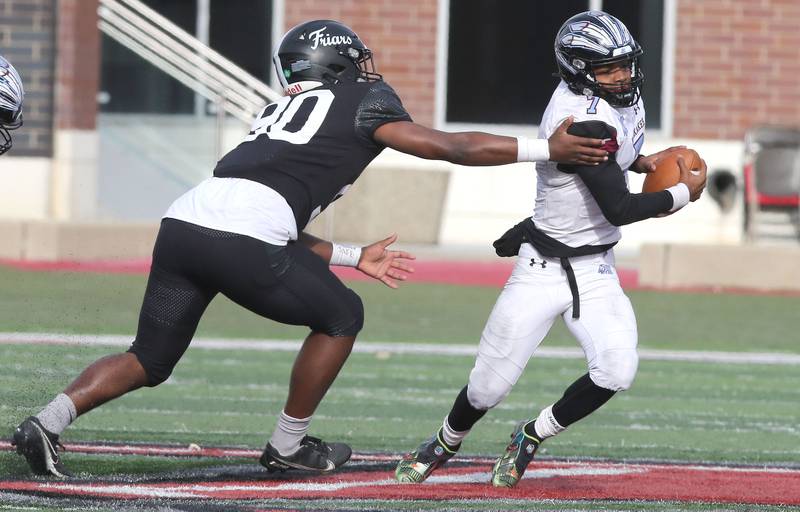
[98,0,281,129]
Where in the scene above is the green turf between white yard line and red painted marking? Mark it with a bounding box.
[0,346,800,472]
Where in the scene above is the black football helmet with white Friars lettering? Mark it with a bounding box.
[272,20,383,94]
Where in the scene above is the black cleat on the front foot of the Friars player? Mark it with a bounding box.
[259,436,353,473]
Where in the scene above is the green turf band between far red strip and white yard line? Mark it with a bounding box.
[0,266,800,353]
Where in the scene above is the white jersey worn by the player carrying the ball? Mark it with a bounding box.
[533,80,644,247]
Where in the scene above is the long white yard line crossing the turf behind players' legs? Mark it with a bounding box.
[0,332,800,366]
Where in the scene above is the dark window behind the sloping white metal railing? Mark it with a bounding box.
[100,0,272,114]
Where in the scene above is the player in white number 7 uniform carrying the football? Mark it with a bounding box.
[395,11,706,487]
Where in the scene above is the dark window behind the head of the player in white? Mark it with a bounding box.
[445,0,664,128]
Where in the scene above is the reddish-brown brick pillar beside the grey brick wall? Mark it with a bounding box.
[55,0,100,130]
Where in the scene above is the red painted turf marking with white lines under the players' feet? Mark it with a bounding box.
[0,462,800,505]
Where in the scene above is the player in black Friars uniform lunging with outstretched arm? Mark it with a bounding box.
[13,20,606,476]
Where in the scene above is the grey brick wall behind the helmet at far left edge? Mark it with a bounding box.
[0,0,56,156]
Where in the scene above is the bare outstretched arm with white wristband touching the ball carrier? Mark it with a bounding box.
[373,118,607,165]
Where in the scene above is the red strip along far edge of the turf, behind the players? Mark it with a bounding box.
[0,259,639,288]
